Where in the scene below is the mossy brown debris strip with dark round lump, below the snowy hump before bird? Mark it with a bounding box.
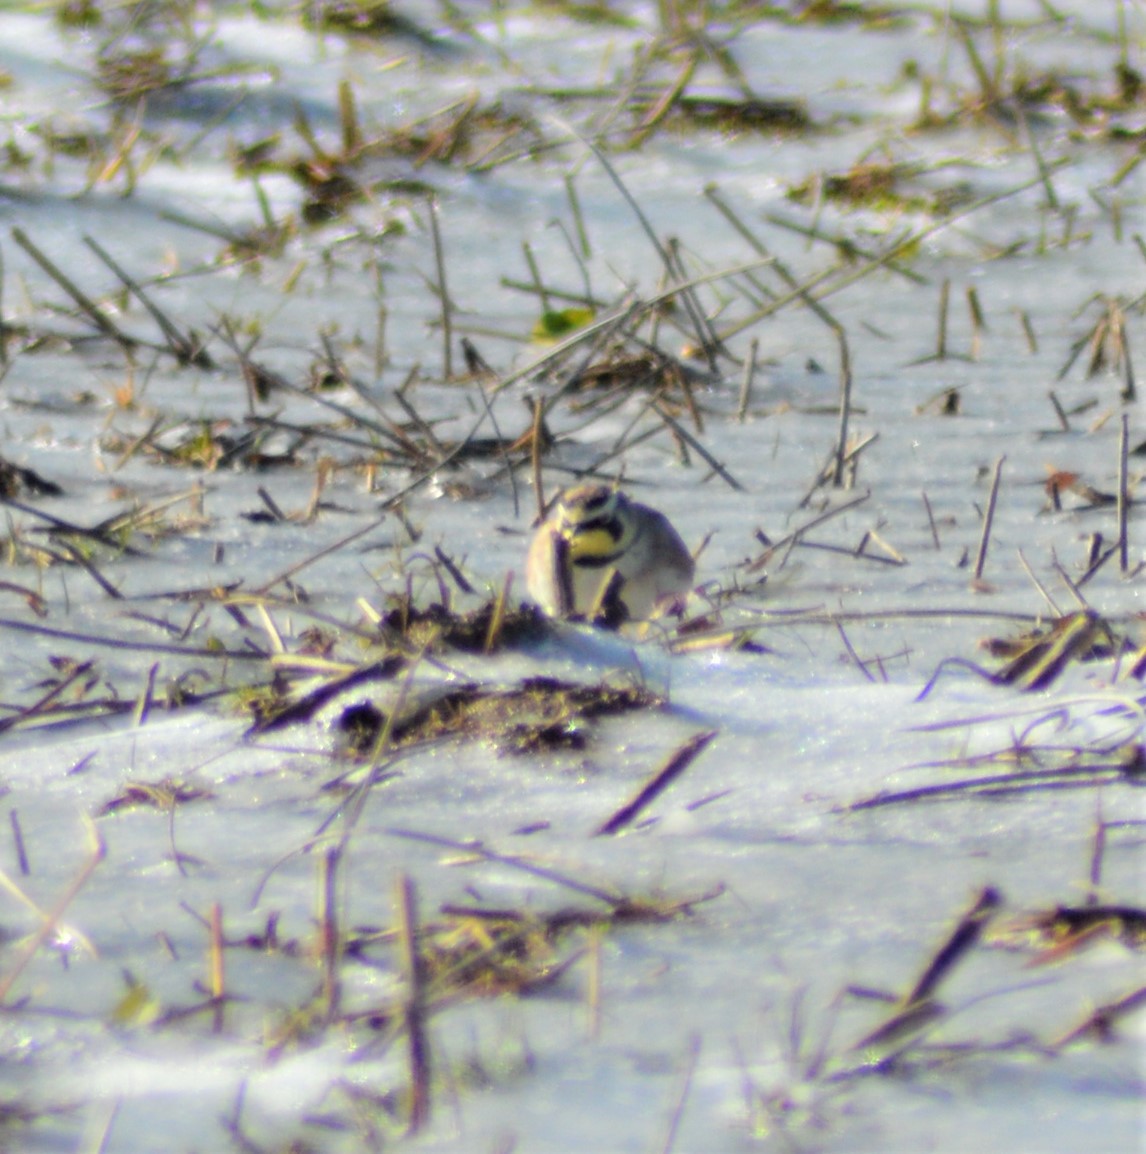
[336,677,664,757]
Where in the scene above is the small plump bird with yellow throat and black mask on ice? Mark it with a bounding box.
[526,485,695,622]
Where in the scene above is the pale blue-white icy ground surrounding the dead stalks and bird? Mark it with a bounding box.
[0,2,1146,1154]
